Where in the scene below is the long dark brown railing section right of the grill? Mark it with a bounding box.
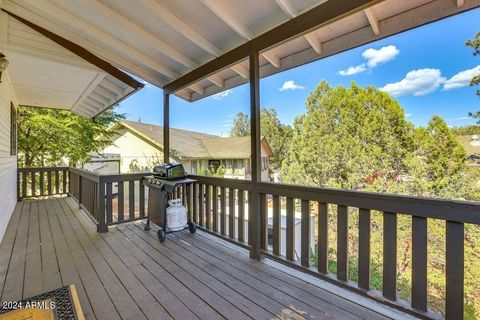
[190,176,480,319]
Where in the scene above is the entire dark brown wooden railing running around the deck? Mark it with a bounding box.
[18,168,480,319]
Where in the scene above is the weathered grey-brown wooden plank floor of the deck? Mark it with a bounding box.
[0,197,409,320]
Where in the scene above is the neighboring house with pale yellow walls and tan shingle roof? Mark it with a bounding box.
[100,121,272,181]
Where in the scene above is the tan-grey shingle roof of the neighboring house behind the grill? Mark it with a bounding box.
[120,120,258,159]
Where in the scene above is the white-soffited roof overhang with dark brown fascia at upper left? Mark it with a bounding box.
[0,11,143,118]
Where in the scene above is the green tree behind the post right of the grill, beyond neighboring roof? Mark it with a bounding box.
[230,108,292,170]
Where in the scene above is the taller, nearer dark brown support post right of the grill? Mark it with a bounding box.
[249,52,262,259]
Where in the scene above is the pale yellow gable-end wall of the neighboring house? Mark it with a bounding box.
[100,129,163,173]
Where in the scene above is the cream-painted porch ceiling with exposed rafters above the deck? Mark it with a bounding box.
[1,0,480,101]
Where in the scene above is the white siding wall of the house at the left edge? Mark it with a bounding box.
[0,73,17,240]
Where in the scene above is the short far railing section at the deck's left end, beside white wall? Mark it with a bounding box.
[17,167,68,201]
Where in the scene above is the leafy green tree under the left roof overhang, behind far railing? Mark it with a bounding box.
[18,107,124,167]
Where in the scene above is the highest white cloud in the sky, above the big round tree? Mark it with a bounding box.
[338,45,400,76]
